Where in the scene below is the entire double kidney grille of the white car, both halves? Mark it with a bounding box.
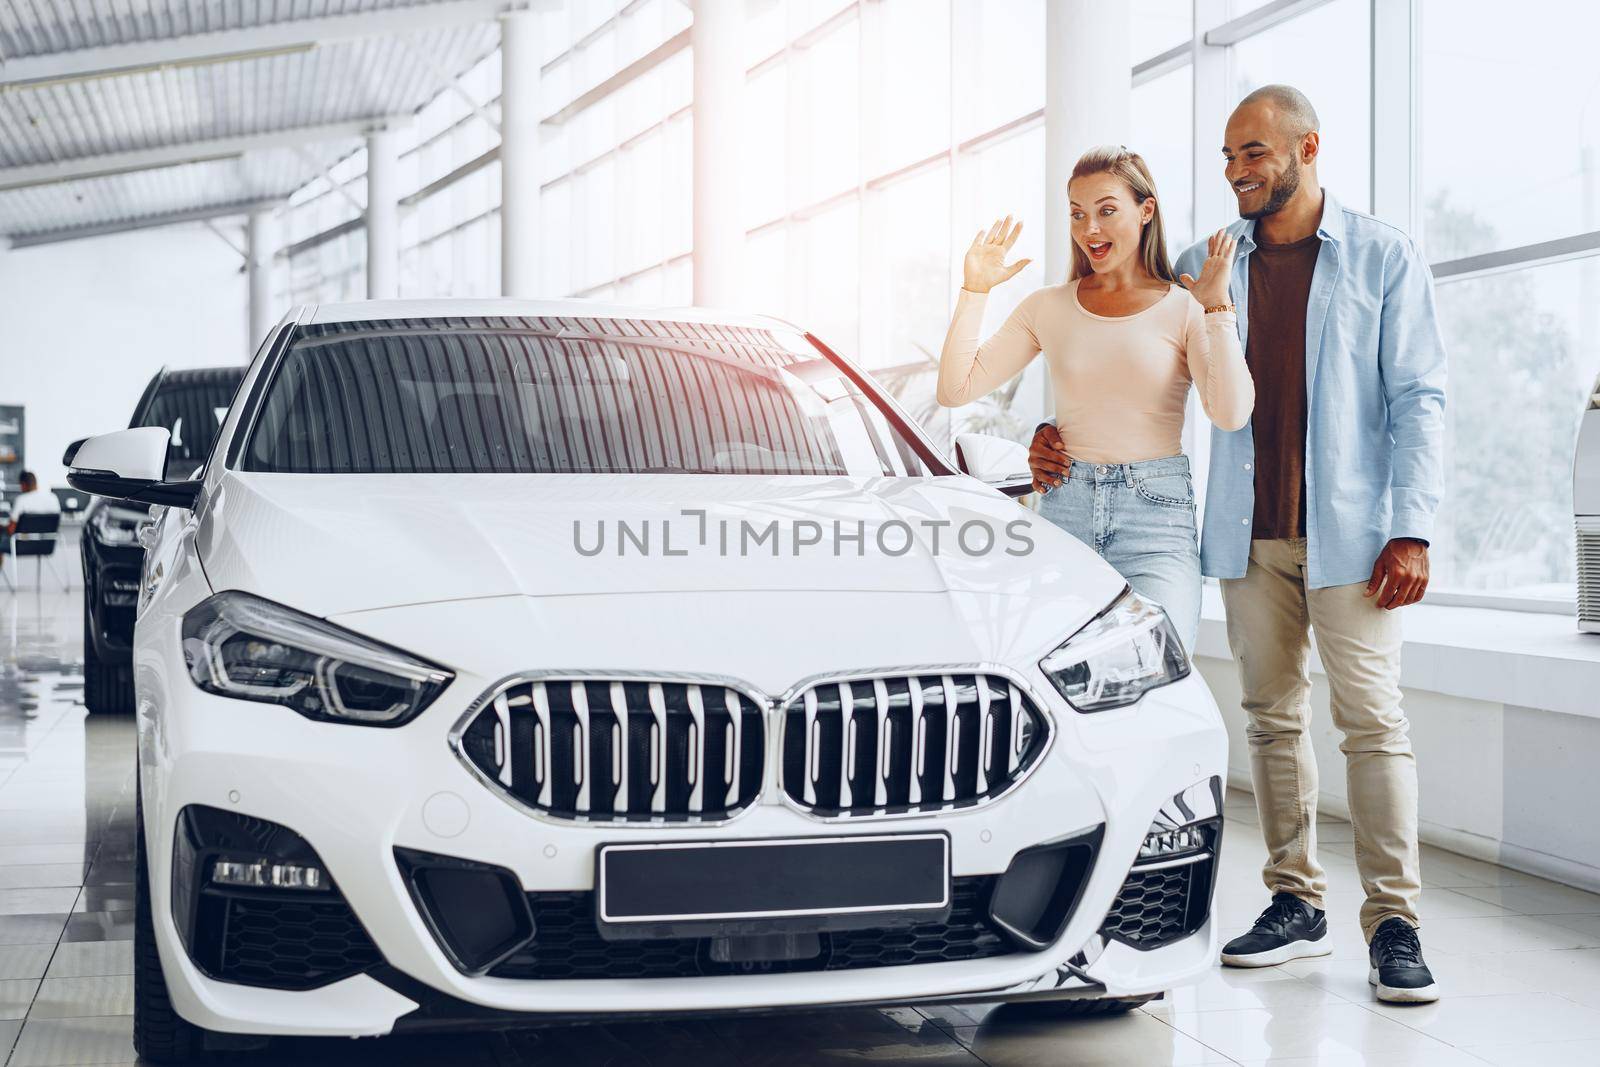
[451,669,1050,822]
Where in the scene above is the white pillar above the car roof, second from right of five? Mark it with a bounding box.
[690,0,744,307]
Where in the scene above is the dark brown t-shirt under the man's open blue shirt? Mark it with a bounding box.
[1245,234,1322,539]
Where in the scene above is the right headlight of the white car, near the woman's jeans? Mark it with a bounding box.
[1038,589,1189,712]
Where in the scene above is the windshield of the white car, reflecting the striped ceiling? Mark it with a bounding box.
[242,318,925,475]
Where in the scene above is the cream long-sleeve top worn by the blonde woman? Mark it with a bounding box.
[938,280,1256,464]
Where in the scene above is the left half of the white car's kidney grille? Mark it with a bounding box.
[456,678,765,822]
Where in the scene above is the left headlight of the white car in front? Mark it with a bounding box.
[184,592,454,726]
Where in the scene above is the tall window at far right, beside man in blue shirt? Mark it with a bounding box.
[1418,0,1600,611]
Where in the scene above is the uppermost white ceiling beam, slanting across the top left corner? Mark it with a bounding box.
[0,0,517,91]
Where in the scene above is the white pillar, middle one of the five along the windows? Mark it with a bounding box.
[501,10,541,298]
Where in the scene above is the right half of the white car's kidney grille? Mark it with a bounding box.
[782,673,1048,817]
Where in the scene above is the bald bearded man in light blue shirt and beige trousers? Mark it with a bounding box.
[1034,85,1445,1003]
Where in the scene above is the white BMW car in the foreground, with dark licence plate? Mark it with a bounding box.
[72,301,1226,1062]
